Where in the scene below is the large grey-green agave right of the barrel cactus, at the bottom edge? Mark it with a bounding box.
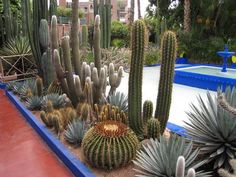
[134,135,210,177]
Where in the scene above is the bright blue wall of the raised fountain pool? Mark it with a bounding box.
[174,65,236,91]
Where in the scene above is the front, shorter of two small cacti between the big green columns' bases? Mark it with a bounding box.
[147,118,161,139]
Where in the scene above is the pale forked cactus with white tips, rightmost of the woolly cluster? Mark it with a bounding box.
[108,63,123,95]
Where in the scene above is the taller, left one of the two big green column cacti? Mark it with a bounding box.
[128,20,145,138]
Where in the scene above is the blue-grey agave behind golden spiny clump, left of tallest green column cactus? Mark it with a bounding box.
[107,92,128,112]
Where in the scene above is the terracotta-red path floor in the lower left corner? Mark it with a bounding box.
[0,89,72,177]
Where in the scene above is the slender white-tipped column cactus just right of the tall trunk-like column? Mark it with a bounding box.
[93,15,101,72]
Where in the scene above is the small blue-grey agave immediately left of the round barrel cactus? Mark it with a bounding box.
[64,119,86,146]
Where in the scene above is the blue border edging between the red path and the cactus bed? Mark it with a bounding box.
[4,88,95,177]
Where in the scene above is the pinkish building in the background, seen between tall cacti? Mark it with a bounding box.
[58,0,128,24]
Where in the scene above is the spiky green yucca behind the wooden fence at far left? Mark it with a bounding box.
[0,37,31,56]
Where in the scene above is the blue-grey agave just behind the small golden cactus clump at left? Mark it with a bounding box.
[43,93,66,109]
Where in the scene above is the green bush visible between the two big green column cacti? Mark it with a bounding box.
[144,47,161,65]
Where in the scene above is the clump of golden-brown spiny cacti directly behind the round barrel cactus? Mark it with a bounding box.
[94,104,128,125]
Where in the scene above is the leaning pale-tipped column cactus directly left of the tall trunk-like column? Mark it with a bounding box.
[61,36,78,107]
